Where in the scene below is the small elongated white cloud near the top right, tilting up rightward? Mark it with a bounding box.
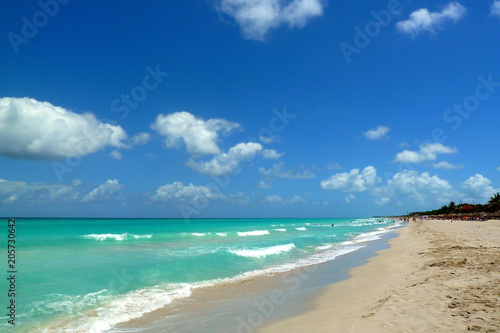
[396,1,467,36]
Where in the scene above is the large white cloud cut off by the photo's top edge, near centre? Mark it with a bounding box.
[216,0,323,41]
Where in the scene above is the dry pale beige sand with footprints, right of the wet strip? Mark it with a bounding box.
[259,220,500,333]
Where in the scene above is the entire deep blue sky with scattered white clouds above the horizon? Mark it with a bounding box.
[0,0,500,218]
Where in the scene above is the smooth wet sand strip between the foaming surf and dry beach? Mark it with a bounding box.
[110,220,404,333]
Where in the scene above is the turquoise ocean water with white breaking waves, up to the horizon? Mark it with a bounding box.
[0,219,398,332]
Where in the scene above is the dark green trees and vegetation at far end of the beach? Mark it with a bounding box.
[408,193,500,217]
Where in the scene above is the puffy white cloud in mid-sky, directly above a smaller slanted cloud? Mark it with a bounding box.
[151,111,240,156]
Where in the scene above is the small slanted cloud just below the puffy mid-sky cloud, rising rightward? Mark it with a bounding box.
[186,142,262,176]
